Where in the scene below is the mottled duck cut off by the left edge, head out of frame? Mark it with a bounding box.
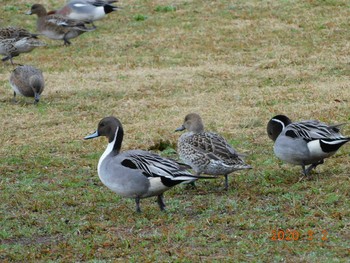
[0,27,46,65]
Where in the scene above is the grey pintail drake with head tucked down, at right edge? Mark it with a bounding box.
[267,115,350,176]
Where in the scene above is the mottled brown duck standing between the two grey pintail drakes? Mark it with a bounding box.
[175,113,251,190]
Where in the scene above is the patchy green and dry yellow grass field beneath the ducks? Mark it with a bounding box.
[0,0,350,262]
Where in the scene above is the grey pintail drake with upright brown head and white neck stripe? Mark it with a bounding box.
[84,116,211,212]
